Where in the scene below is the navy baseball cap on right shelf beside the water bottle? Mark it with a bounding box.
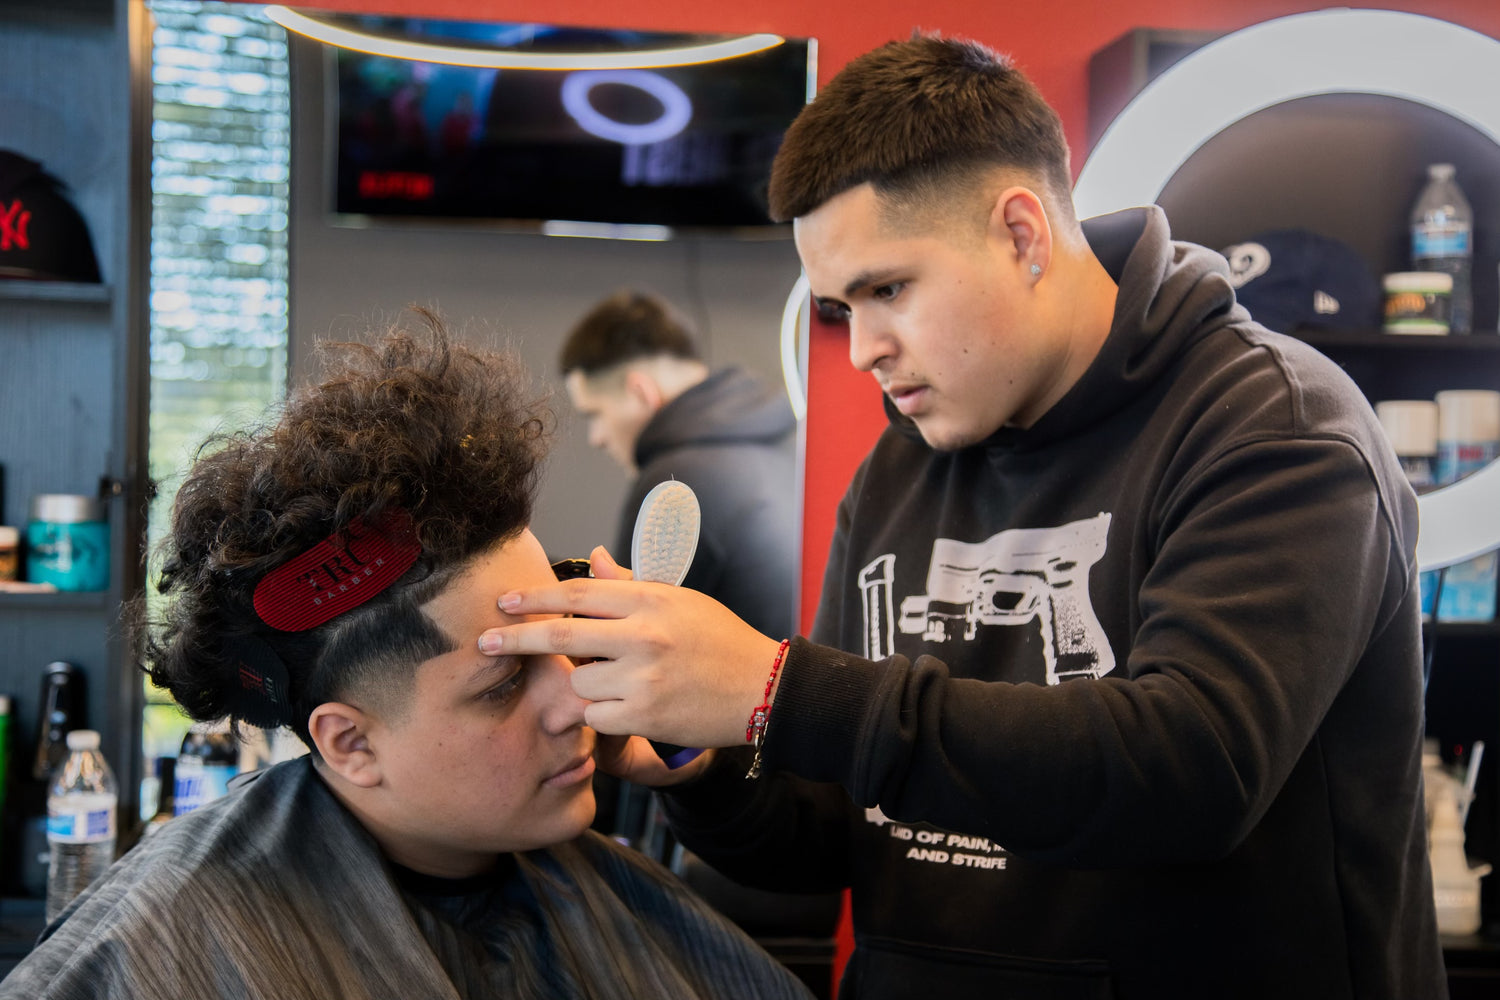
[1223,229,1380,333]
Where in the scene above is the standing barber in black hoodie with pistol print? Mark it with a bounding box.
[480,36,1446,1000]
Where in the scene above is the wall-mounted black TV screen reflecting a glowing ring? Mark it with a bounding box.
[330,16,816,229]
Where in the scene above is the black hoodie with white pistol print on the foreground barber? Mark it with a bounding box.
[668,208,1446,1000]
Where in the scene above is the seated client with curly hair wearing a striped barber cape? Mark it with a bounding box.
[0,313,807,1000]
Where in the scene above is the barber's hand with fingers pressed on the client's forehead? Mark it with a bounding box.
[480,547,780,755]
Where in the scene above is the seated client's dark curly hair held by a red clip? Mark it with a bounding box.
[137,309,552,747]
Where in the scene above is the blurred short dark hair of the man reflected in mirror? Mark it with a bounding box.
[558,288,702,375]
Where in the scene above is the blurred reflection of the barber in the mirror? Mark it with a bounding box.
[560,289,800,634]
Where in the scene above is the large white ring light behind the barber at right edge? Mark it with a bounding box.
[1073,10,1500,570]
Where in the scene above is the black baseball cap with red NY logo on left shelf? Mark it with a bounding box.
[0,150,99,282]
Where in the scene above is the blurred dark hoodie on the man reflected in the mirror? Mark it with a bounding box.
[614,367,801,639]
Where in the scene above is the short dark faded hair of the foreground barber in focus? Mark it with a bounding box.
[770,34,1073,222]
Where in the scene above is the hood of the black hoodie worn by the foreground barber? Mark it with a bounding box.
[885,205,1250,448]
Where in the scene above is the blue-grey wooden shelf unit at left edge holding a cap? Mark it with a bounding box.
[0,0,150,895]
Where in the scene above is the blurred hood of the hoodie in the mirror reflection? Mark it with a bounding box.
[636,367,797,468]
